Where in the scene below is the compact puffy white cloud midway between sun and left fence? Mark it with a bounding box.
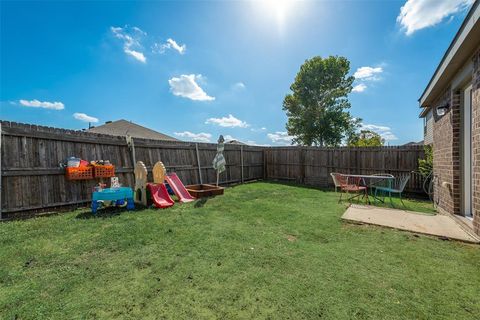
[168,74,215,101]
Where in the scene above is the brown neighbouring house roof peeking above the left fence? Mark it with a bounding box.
[88,119,179,141]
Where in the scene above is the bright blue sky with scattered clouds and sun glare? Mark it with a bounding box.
[0,0,472,145]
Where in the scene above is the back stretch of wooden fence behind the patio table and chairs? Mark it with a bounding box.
[265,146,424,193]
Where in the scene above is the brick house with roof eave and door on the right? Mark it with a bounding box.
[419,0,480,234]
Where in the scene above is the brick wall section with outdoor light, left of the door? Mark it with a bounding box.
[433,88,460,214]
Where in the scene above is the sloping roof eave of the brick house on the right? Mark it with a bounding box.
[419,0,480,116]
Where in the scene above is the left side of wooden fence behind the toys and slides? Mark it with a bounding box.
[1,121,264,218]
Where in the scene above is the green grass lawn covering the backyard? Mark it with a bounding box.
[0,183,480,319]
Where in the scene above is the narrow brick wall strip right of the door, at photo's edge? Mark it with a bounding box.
[472,48,480,234]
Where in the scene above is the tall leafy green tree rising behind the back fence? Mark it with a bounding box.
[283,56,360,147]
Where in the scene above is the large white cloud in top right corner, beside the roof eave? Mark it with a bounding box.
[397,0,474,35]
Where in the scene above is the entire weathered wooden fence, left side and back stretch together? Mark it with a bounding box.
[0,121,423,219]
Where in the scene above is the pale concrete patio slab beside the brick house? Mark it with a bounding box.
[342,205,480,243]
